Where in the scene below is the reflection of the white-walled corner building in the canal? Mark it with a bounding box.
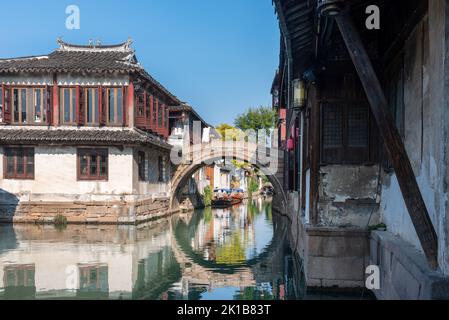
[0,223,174,299]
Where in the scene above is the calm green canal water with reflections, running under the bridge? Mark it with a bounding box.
[0,198,368,300]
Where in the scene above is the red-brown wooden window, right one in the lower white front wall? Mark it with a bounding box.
[77,148,108,180]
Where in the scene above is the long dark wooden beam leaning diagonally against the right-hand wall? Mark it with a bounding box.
[336,13,438,270]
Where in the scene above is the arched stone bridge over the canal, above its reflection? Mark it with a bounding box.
[170,140,287,212]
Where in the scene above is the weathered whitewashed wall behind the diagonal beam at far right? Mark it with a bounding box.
[380,5,449,274]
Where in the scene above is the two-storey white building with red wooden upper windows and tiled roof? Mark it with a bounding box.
[0,40,180,223]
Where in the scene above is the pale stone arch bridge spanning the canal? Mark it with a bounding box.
[170,141,287,213]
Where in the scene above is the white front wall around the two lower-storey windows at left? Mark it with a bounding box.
[0,147,133,201]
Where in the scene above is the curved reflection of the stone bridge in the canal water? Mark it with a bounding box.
[166,214,287,292]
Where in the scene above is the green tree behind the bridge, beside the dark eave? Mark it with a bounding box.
[234,106,277,131]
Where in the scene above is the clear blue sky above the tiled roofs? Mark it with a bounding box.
[0,0,279,125]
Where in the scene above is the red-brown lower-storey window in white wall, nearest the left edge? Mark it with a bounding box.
[3,148,34,180]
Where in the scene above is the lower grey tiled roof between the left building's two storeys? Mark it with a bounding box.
[0,129,171,149]
